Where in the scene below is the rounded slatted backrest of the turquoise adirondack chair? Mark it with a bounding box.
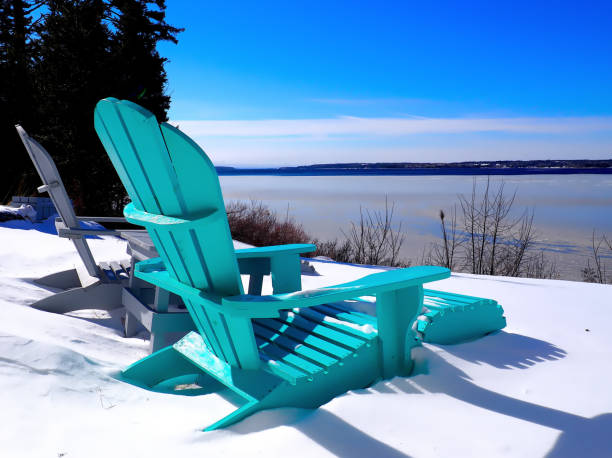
[95,98,254,366]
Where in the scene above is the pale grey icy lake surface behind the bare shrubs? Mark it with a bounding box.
[220,175,612,279]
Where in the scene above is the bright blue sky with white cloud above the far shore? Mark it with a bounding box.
[159,0,612,166]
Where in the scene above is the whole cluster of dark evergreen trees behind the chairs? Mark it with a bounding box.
[0,0,182,214]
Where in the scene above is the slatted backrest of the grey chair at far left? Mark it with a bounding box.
[15,125,100,277]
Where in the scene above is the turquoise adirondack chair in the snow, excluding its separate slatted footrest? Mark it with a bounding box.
[95,98,450,430]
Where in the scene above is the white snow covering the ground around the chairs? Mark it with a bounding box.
[0,220,612,458]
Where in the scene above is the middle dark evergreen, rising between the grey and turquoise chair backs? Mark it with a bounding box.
[35,0,117,213]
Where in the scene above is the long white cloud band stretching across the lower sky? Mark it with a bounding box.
[172,117,612,138]
